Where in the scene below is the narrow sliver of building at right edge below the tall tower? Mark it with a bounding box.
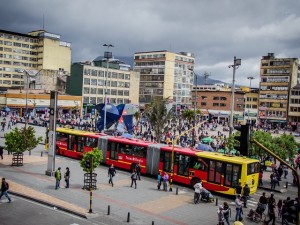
[288,84,300,132]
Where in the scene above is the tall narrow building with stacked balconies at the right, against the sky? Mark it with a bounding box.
[258,53,298,127]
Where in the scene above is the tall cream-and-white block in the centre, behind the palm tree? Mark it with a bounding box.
[134,50,195,106]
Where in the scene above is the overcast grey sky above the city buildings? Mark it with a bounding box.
[0,0,300,87]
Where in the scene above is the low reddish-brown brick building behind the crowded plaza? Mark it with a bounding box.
[192,90,245,123]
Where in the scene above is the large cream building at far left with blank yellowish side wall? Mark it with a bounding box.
[0,30,71,91]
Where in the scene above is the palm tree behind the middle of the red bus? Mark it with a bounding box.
[145,98,173,142]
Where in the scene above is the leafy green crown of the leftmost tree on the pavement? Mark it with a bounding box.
[4,126,43,153]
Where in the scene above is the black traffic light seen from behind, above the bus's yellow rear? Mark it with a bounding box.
[234,124,250,156]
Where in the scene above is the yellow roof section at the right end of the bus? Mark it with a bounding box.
[196,151,259,164]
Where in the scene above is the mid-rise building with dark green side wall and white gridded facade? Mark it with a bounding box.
[67,60,140,114]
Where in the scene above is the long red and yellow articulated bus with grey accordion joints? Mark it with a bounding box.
[56,128,259,195]
